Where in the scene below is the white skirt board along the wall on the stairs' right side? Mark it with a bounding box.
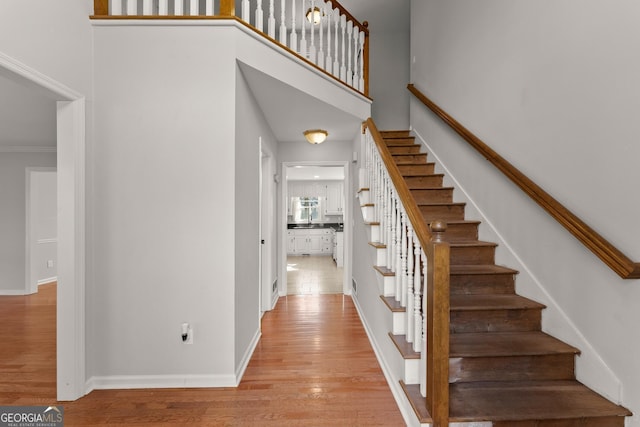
[412,129,622,402]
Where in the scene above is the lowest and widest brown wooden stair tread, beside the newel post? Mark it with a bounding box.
[450,380,631,422]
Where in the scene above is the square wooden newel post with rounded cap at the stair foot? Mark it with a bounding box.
[425,221,450,427]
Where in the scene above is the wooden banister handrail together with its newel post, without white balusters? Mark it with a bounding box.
[363,118,450,427]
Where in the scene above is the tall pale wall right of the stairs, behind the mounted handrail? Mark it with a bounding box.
[411,0,640,426]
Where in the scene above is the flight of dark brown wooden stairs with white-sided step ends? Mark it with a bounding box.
[365,131,631,427]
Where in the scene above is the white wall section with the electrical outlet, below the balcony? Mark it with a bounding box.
[87,26,239,387]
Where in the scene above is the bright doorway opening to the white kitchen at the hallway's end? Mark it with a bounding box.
[281,162,350,295]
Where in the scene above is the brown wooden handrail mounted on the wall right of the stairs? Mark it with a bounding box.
[407,84,640,279]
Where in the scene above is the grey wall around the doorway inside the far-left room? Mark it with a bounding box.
[0,152,56,295]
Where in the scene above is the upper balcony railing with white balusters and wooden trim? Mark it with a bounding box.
[91,0,369,96]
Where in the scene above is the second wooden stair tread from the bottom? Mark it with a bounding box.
[449,331,580,357]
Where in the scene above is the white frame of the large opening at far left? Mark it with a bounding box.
[0,52,86,401]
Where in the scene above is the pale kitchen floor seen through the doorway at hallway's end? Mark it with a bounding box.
[287,256,344,295]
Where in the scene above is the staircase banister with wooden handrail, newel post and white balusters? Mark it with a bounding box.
[363,119,450,427]
